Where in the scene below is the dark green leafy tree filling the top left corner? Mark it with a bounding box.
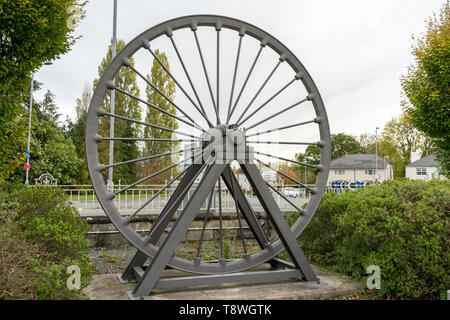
[0,0,85,183]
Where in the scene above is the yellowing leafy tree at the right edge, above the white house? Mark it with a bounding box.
[401,0,450,172]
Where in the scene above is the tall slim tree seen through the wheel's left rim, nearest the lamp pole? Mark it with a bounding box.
[94,40,142,184]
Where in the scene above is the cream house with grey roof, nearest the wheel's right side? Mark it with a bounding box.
[328,154,394,183]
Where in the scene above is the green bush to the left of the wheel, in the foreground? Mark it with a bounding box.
[0,186,92,299]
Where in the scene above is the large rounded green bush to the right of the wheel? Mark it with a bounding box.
[292,180,450,299]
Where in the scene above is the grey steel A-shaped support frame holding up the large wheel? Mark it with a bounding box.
[123,164,318,299]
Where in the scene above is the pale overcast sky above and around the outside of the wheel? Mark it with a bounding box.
[36,0,443,142]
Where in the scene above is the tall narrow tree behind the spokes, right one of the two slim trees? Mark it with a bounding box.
[143,50,178,181]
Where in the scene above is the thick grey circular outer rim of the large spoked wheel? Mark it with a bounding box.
[86,15,330,274]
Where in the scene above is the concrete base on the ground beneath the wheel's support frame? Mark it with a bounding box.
[84,265,361,300]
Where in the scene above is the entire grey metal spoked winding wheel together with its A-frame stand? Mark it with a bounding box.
[86,15,330,298]
